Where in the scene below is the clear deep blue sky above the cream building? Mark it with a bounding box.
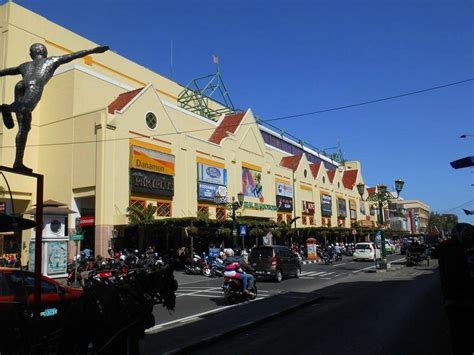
[8,0,474,223]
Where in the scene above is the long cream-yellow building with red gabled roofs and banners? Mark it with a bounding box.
[0,2,382,264]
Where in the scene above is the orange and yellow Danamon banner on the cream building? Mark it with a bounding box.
[130,145,174,175]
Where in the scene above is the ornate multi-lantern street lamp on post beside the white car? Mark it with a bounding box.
[357,179,405,270]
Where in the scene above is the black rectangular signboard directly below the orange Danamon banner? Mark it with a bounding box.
[130,169,174,197]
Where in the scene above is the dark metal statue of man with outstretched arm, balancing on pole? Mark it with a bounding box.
[0,43,109,172]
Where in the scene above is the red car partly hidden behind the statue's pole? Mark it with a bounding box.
[0,267,82,353]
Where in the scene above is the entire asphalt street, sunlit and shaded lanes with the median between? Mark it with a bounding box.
[142,255,450,355]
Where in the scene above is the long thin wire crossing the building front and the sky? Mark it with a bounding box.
[2,78,474,150]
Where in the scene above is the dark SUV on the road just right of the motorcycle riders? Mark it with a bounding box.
[249,245,301,282]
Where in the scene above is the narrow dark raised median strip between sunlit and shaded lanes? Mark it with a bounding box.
[140,292,322,354]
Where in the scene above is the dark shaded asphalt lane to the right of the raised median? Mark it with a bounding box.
[192,263,451,355]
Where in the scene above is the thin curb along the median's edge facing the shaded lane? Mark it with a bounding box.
[163,294,324,355]
